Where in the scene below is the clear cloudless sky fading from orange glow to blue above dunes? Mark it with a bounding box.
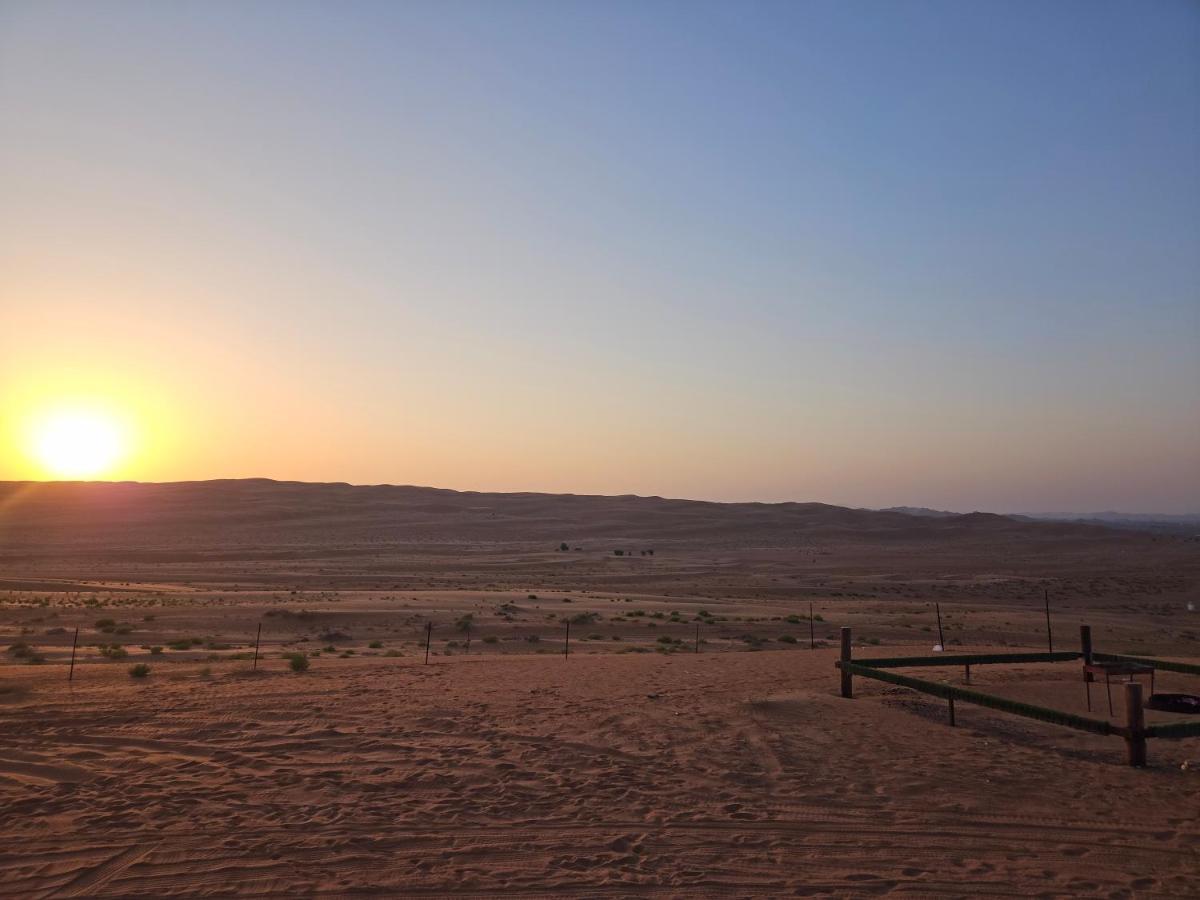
[0,0,1200,512]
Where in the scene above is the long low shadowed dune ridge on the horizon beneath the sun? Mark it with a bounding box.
[0,479,1121,550]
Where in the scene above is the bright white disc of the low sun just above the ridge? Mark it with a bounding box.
[30,409,128,479]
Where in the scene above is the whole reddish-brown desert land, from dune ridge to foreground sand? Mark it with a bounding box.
[0,480,1200,898]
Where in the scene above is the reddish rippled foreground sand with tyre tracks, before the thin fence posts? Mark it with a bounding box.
[0,607,1200,896]
